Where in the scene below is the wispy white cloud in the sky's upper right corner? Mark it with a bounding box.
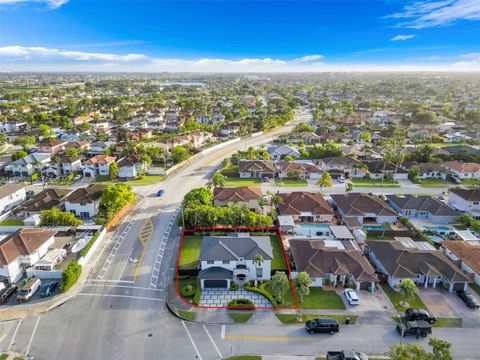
[386,0,480,29]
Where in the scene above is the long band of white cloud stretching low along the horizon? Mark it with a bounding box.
[0,45,480,73]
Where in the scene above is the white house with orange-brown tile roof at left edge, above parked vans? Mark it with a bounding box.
[0,228,56,283]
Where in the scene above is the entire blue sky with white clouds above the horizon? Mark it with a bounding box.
[0,0,480,72]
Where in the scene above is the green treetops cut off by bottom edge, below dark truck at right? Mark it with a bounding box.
[388,338,453,360]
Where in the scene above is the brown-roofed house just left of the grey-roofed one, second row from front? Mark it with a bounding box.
[331,193,398,226]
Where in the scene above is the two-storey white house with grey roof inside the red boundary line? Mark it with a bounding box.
[198,233,273,289]
